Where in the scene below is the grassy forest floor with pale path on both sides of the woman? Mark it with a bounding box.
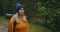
[0,16,52,32]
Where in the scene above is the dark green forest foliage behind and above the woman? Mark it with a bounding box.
[0,0,60,32]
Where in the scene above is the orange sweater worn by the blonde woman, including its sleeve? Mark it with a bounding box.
[8,17,29,32]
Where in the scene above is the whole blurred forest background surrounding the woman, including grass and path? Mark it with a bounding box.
[0,0,60,32]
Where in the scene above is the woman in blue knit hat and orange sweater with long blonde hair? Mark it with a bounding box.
[8,3,29,32]
